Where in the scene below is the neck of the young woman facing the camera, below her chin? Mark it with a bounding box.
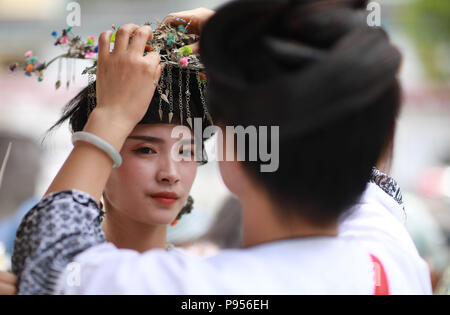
[102,206,167,253]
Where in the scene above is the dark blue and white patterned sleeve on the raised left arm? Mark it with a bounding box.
[12,190,105,294]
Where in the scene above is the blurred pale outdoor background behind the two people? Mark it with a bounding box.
[0,0,450,293]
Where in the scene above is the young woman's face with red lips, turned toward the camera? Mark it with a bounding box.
[103,124,197,225]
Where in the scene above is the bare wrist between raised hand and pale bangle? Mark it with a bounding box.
[83,108,135,152]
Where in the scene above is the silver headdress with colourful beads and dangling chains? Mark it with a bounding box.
[9,18,213,128]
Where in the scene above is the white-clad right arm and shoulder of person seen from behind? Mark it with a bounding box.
[339,181,431,294]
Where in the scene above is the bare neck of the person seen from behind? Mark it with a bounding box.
[241,186,338,247]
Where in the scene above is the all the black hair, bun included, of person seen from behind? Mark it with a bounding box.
[200,0,401,226]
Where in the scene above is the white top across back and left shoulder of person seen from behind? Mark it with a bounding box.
[57,241,373,294]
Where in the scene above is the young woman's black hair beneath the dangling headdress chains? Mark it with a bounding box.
[48,67,211,164]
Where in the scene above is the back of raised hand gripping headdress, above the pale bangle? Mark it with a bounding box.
[96,24,162,132]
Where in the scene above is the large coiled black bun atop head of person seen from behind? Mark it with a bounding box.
[200,0,401,136]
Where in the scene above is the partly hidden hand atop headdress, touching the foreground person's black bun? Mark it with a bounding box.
[163,8,216,54]
